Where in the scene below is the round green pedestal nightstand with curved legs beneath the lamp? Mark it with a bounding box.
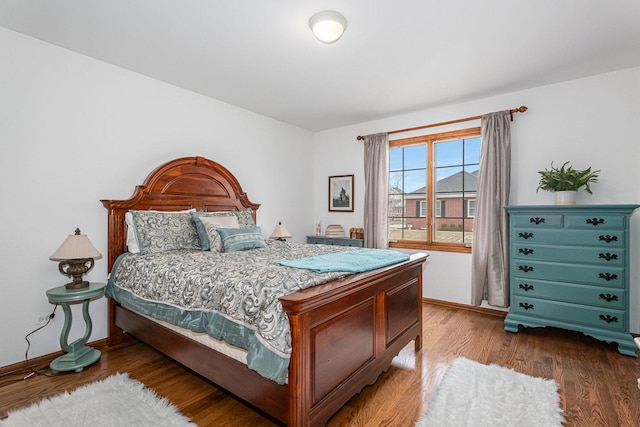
[47,283,107,374]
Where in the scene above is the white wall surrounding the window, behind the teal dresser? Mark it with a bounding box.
[316,68,640,332]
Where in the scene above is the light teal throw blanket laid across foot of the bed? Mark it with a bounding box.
[280,249,409,273]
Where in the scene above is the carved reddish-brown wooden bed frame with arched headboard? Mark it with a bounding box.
[102,157,426,427]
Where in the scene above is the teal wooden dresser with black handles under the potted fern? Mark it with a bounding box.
[504,205,640,357]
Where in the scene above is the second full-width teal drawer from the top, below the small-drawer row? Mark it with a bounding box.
[511,243,626,266]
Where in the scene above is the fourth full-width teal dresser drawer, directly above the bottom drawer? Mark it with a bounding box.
[512,278,626,310]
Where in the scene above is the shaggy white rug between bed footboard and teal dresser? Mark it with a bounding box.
[416,357,564,427]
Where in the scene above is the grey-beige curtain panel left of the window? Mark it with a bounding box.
[363,132,389,248]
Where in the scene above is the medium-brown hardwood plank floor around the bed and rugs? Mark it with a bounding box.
[0,304,640,427]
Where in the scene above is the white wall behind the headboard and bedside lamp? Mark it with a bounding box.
[0,28,314,366]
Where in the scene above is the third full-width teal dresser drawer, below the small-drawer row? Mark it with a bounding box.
[511,259,626,288]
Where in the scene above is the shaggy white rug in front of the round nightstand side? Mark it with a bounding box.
[0,374,195,427]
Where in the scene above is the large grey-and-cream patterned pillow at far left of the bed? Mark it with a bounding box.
[131,211,201,255]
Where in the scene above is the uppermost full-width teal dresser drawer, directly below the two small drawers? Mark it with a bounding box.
[511,231,626,248]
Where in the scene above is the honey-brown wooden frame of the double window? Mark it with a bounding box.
[387,127,480,253]
